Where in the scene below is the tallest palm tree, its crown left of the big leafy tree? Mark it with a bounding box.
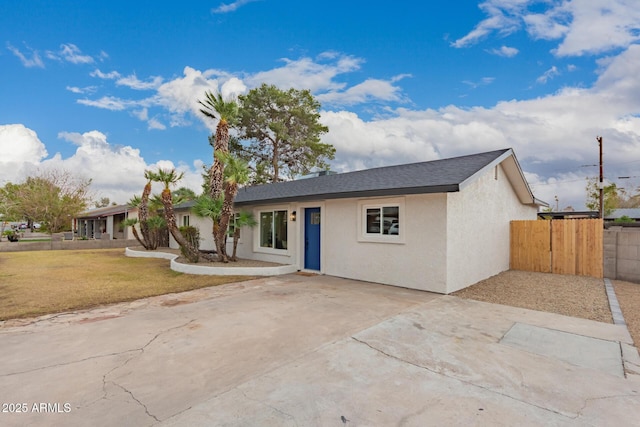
[198,91,238,199]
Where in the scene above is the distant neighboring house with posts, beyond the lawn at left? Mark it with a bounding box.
[73,205,133,239]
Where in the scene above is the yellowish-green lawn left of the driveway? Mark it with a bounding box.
[0,249,253,320]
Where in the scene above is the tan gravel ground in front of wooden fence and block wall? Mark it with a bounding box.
[452,270,640,347]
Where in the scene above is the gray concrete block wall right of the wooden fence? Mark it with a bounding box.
[604,227,640,283]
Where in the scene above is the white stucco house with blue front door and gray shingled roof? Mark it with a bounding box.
[169,149,544,294]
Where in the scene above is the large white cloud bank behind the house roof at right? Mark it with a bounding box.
[321,46,640,209]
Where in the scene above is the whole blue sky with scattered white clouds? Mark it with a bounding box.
[0,0,640,209]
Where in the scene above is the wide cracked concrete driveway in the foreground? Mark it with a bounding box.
[0,274,640,426]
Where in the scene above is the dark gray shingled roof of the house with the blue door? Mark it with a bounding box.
[235,149,510,205]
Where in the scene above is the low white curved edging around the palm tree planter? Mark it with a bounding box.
[125,248,298,276]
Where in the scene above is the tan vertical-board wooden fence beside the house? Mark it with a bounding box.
[510,219,604,278]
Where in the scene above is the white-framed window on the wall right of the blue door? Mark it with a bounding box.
[358,198,406,243]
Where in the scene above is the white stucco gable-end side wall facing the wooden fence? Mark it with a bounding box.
[446,166,538,293]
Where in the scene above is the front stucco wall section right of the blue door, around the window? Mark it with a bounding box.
[322,194,446,292]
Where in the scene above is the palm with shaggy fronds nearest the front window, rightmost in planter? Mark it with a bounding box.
[216,152,249,262]
